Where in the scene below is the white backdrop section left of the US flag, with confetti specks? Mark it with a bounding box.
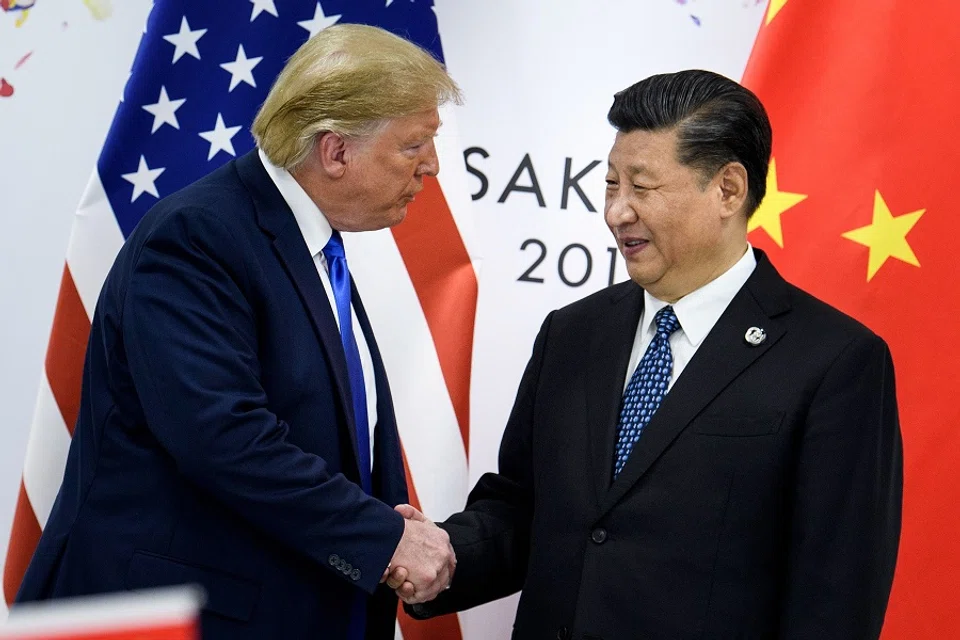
[0,0,151,596]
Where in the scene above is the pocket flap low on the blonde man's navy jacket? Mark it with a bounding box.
[127,551,260,622]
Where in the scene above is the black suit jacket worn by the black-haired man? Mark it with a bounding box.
[414,251,902,640]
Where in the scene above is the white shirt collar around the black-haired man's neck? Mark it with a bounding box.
[643,243,757,347]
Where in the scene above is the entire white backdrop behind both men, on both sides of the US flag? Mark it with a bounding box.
[0,0,766,640]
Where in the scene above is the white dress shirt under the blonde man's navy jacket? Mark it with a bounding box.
[258,150,377,468]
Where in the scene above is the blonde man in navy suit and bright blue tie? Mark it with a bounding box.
[18,25,460,640]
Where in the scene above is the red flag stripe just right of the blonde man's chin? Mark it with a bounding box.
[392,177,477,456]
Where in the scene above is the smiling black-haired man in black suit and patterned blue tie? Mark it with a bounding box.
[396,71,903,640]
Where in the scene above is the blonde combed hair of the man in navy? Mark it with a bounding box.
[252,24,462,170]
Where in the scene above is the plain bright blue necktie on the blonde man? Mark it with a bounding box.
[323,231,373,494]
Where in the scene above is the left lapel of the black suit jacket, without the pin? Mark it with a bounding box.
[586,283,643,505]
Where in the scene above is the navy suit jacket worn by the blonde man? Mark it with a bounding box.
[17,152,407,640]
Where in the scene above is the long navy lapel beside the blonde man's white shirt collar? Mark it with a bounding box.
[236,149,360,478]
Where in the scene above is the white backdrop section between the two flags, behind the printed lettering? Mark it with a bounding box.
[430,0,766,640]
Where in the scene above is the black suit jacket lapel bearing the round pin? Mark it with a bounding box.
[601,251,789,513]
